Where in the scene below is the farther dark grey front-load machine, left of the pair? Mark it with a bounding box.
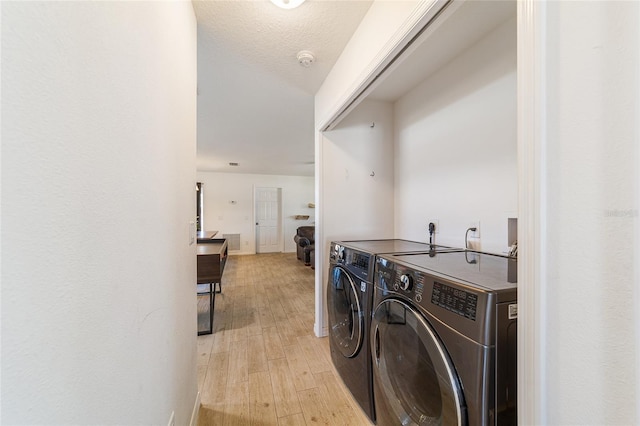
[327,239,460,422]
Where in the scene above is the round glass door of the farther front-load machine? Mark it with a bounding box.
[327,266,364,358]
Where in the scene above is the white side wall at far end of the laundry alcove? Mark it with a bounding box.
[316,101,393,332]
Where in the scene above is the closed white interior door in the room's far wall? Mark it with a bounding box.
[256,188,282,253]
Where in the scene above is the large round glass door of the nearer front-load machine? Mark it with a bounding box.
[371,299,467,425]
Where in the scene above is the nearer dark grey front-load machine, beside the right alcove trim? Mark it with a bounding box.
[370,251,517,426]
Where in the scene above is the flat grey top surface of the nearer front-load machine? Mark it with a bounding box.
[384,251,517,291]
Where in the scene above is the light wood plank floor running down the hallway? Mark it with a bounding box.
[198,253,372,426]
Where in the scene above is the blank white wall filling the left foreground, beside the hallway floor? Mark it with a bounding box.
[1,1,197,425]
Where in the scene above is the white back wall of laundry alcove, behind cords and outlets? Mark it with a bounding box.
[394,17,518,253]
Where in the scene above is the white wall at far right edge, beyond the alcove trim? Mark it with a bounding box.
[536,2,640,425]
